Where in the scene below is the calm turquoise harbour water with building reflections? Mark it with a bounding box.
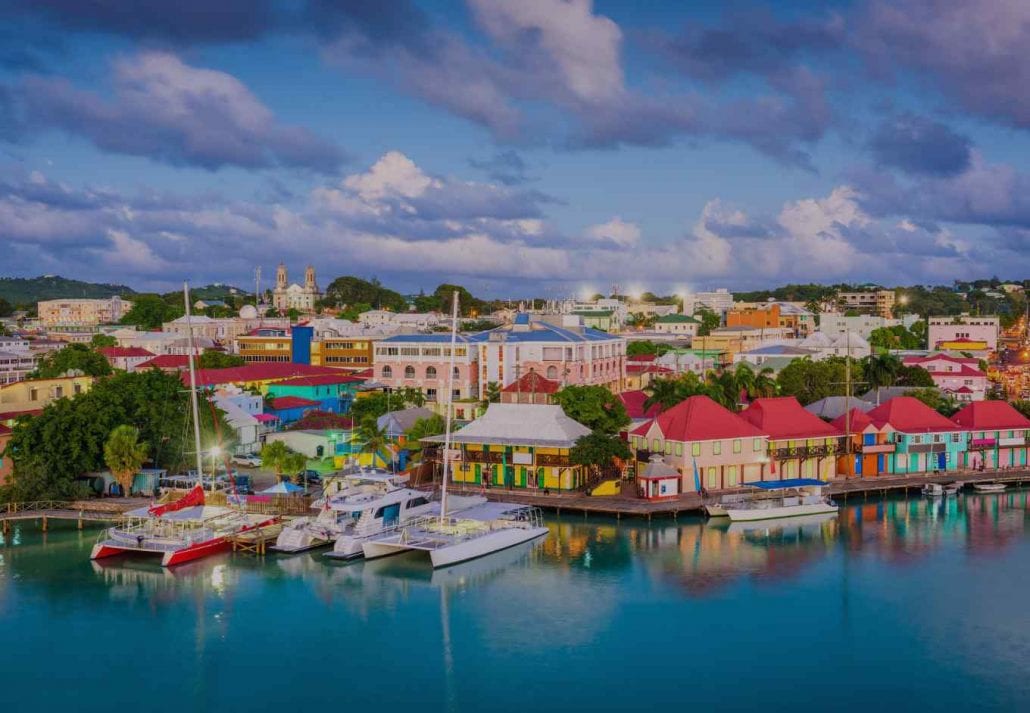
[0,493,1030,713]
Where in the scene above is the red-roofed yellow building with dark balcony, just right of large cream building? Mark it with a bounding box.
[741,396,844,480]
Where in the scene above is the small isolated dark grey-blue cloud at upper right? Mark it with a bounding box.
[869,114,971,176]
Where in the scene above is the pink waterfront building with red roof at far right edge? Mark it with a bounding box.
[952,401,1030,469]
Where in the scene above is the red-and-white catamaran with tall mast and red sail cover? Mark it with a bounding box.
[90,283,276,567]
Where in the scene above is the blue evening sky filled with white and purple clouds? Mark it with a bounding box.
[0,0,1030,298]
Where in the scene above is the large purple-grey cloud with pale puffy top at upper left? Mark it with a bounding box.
[15,52,344,172]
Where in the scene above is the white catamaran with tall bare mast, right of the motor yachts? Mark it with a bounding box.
[362,292,549,568]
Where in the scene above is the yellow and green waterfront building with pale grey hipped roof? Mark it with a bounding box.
[422,404,590,490]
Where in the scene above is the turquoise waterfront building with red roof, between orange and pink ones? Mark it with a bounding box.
[867,396,967,474]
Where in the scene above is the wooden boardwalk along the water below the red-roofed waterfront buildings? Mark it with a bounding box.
[450,468,1030,519]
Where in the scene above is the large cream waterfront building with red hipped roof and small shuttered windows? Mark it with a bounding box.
[629,396,779,493]
